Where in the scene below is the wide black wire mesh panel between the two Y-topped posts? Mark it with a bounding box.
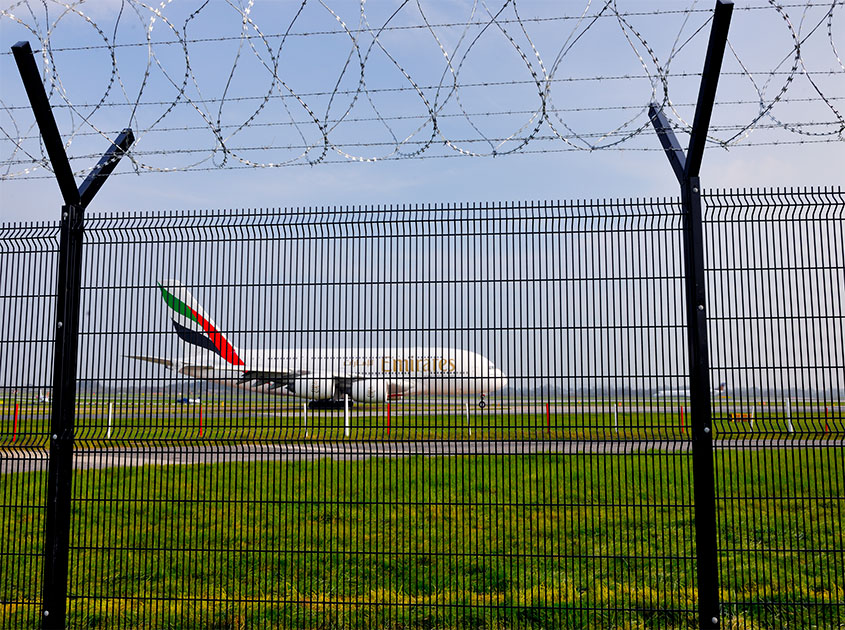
[51,202,696,628]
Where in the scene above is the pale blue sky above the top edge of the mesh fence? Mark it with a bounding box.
[0,0,845,221]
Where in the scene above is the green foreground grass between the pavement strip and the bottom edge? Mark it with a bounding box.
[0,447,845,629]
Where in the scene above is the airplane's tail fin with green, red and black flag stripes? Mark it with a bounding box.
[158,280,244,365]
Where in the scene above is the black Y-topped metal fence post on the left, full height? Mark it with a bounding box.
[12,41,135,628]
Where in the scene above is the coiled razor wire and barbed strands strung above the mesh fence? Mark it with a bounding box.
[0,0,845,179]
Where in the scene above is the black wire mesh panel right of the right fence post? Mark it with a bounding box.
[706,191,845,628]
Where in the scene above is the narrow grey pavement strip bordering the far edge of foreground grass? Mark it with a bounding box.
[0,438,845,474]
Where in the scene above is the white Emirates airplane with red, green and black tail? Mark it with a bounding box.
[128,280,507,409]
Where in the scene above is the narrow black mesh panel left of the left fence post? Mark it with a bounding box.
[0,224,58,628]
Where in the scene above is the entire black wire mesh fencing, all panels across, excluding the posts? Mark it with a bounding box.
[0,190,845,628]
